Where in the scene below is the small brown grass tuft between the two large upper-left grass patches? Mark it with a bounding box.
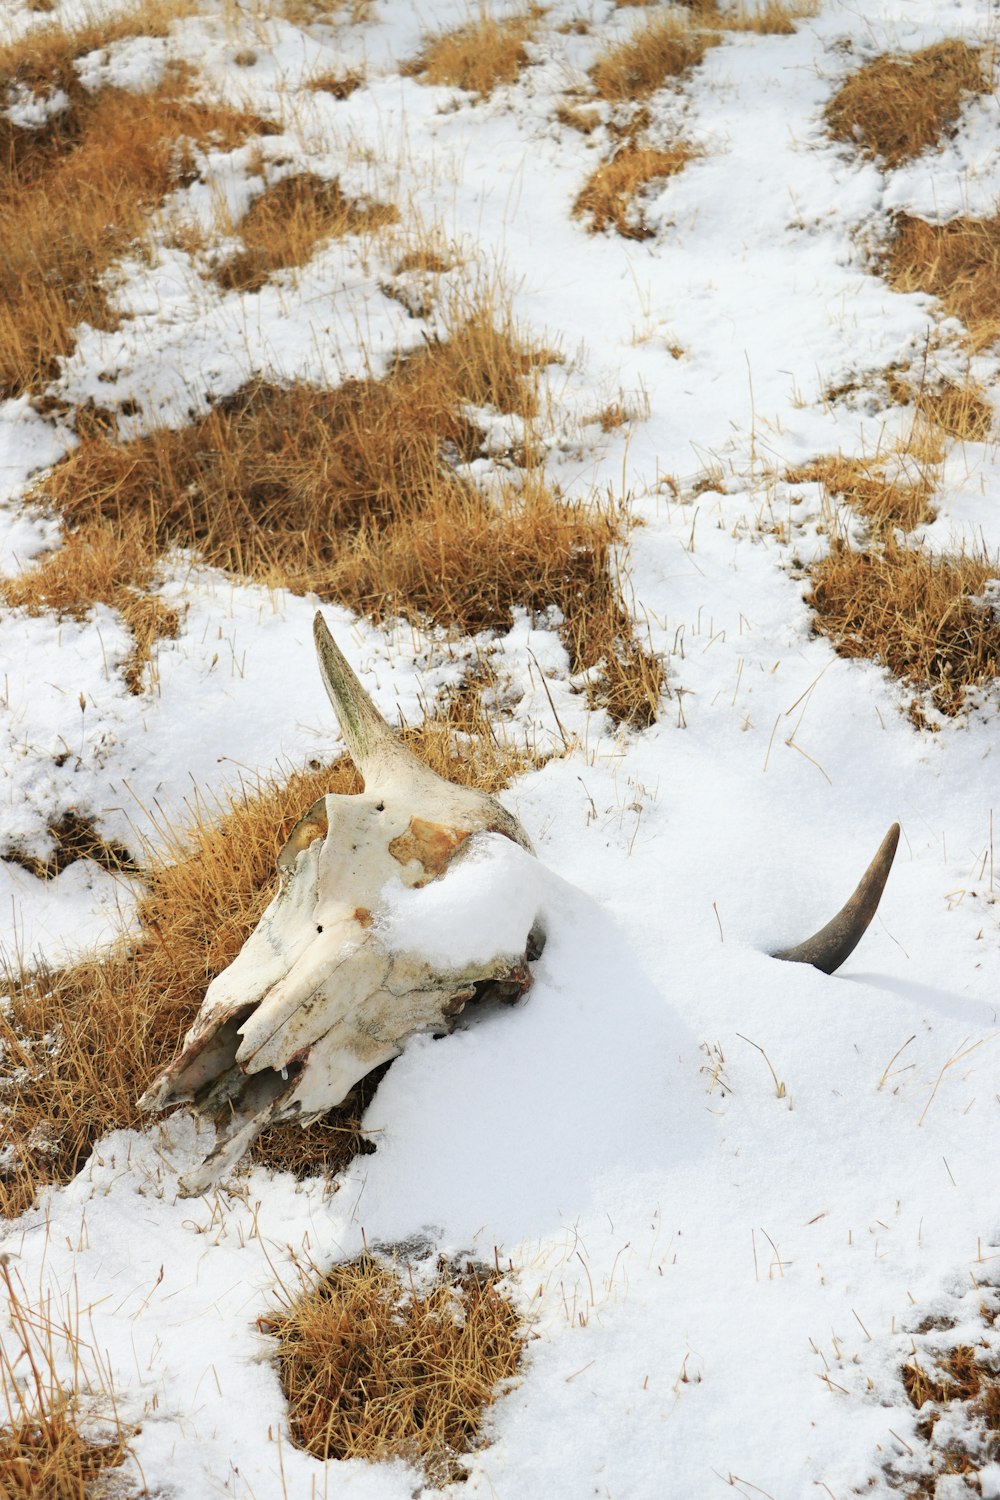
[216,173,399,291]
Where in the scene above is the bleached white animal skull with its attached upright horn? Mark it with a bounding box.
[139,615,544,1194]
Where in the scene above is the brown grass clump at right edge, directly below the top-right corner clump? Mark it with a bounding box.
[885,213,1000,350]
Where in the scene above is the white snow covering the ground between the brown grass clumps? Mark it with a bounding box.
[0,0,1000,1500]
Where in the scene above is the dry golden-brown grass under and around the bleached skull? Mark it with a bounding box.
[0,687,540,1218]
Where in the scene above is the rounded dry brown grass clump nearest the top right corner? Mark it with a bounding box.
[825,39,993,167]
